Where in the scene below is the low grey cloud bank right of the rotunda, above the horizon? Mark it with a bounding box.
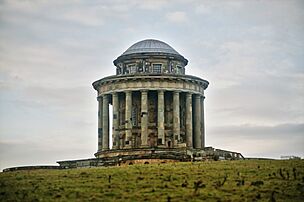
[207,123,304,158]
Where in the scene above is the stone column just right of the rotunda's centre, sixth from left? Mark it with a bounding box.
[157,90,165,145]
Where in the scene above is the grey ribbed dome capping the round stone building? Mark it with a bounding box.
[121,39,180,56]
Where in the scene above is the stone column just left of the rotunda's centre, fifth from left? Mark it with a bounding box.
[141,91,148,146]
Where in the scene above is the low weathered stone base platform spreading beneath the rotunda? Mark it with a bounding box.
[57,147,245,168]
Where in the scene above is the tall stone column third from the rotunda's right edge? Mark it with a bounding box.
[186,93,193,148]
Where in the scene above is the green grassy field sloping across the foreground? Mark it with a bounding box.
[0,160,304,201]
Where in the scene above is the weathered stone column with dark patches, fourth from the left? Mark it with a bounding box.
[125,91,132,148]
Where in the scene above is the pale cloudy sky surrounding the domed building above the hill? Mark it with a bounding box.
[0,0,304,169]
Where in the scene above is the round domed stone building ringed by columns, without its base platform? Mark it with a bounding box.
[93,39,209,157]
